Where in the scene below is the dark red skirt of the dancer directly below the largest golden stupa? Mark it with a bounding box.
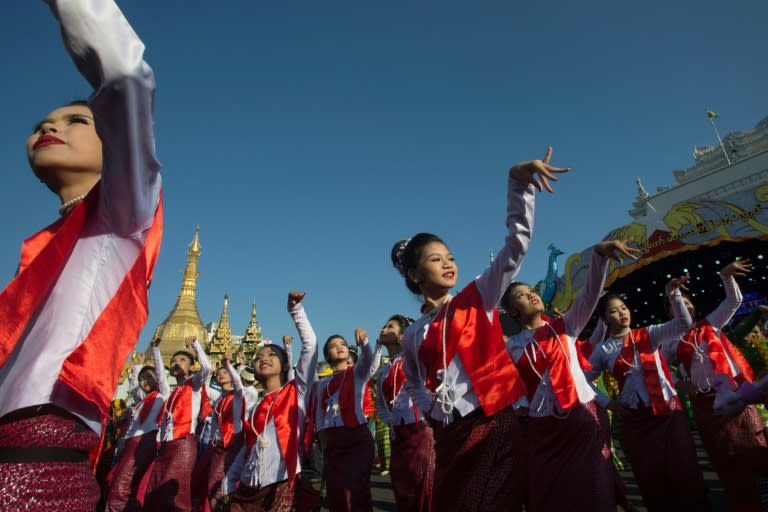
[144,434,197,512]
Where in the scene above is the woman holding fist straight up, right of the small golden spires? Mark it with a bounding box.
[224,291,317,512]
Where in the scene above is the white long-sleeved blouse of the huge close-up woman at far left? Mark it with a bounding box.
[0,0,161,433]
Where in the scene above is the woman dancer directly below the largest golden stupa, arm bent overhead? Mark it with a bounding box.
[144,336,211,512]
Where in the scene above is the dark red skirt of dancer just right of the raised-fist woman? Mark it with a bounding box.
[322,425,374,512]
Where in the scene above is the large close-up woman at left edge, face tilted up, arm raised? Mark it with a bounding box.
[0,0,162,511]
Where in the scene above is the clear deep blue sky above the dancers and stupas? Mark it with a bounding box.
[0,0,768,360]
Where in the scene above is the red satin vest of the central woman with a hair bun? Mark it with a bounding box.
[419,281,525,416]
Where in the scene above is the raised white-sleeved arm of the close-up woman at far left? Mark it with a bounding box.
[47,0,160,236]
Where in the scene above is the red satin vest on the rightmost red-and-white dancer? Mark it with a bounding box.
[677,318,754,386]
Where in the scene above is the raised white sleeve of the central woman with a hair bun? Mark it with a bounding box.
[476,178,536,310]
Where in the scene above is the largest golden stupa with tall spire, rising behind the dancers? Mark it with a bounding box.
[147,226,208,365]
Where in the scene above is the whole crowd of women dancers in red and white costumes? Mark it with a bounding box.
[0,0,768,512]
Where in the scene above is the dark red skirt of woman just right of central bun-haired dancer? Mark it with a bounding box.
[528,401,616,512]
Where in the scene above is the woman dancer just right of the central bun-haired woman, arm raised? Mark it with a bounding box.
[501,240,639,512]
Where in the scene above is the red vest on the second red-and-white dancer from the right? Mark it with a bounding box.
[613,327,678,416]
